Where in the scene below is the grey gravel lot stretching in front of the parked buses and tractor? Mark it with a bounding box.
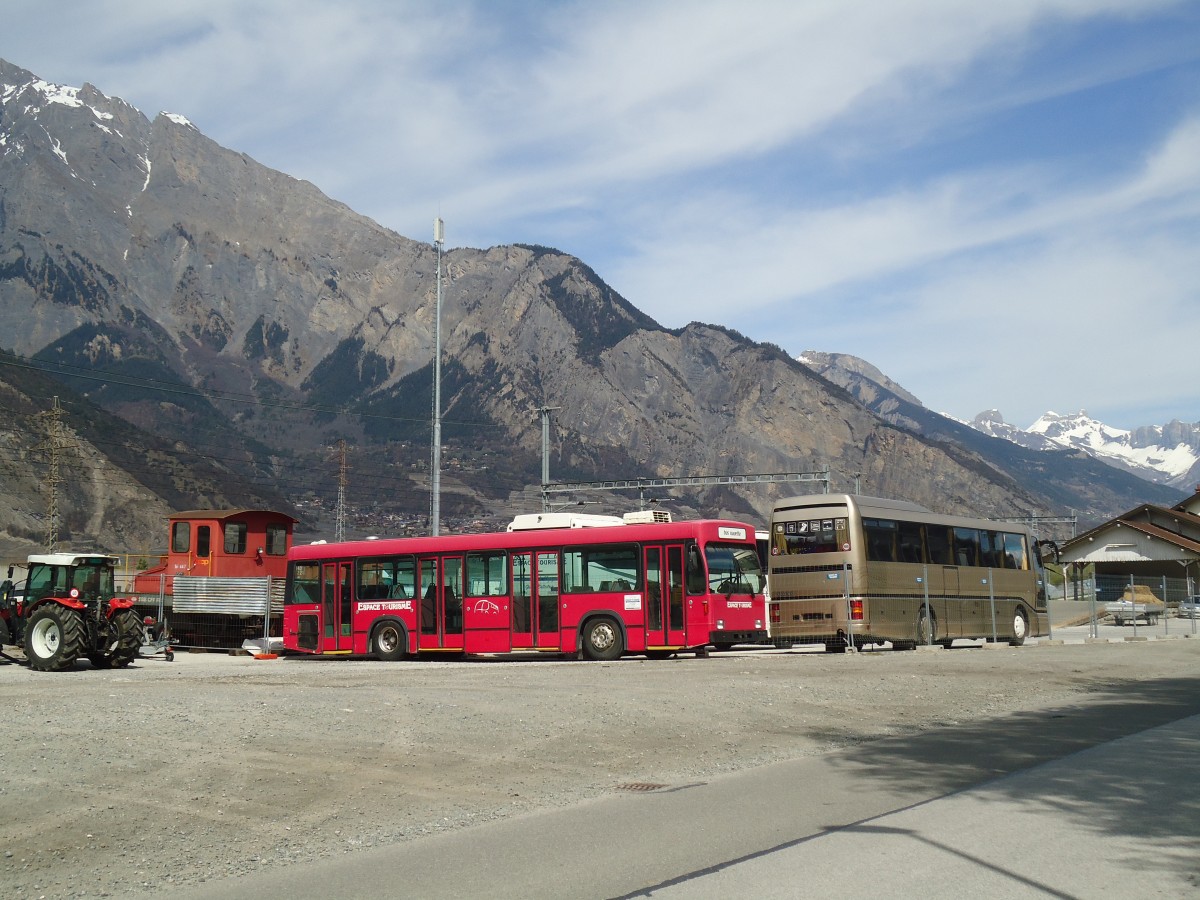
[0,634,1200,899]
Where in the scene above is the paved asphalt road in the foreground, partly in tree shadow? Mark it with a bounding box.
[176,657,1200,900]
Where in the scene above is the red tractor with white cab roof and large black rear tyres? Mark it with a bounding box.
[0,553,144,672]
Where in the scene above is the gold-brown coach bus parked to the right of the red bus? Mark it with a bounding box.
[768,494,1049,652]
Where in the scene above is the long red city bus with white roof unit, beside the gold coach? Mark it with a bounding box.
[283,514,767,660]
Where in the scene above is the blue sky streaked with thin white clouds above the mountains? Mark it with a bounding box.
[0,0,1200,428]
